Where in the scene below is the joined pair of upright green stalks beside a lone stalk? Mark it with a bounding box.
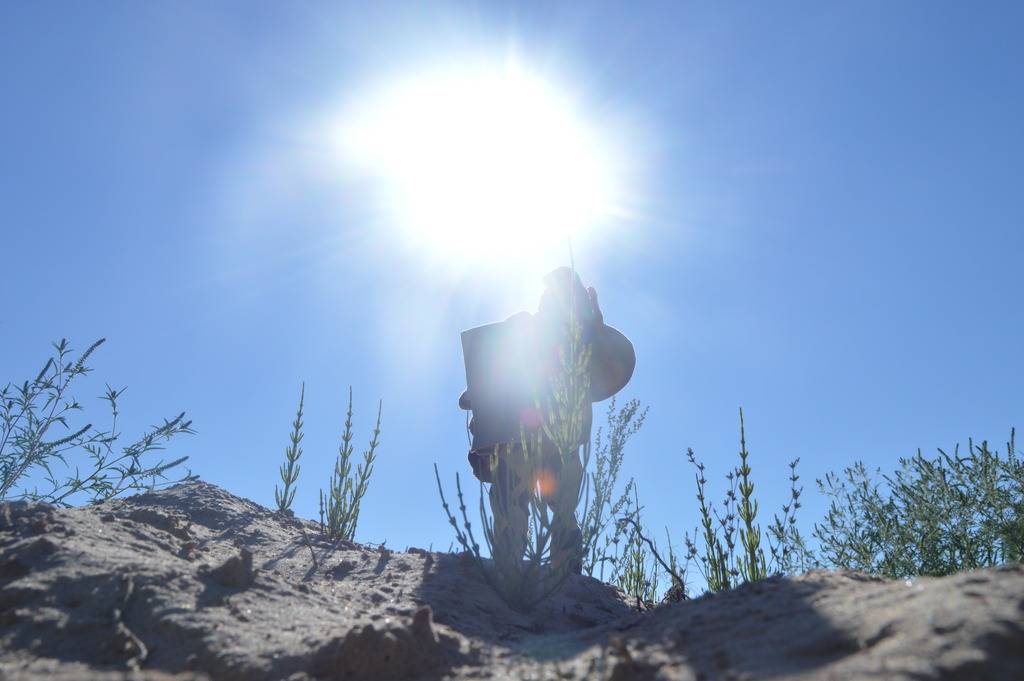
[319,387,384,541]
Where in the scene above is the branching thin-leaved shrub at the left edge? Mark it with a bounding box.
[0,339,195,506]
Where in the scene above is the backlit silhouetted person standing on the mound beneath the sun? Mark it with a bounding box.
[459,267,636,572]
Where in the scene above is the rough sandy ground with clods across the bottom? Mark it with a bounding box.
[0,482,1024,681]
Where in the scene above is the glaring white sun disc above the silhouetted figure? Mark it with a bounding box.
[337,65,616,265]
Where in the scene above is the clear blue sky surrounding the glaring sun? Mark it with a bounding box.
[0,2,1024,548]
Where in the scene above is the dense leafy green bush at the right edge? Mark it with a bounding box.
[814,431,1024,578]
